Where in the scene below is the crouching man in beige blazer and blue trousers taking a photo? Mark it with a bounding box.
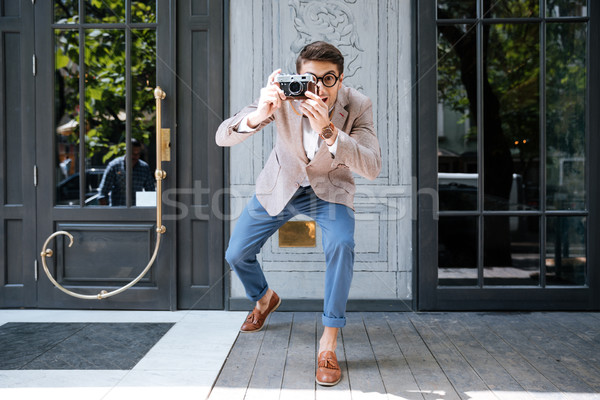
[216,42,381,386]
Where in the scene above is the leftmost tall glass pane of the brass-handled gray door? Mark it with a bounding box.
[54,30,79,205]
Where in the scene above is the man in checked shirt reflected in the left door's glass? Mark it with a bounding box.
[98,139,155,206]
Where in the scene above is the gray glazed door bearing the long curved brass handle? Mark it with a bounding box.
[34,0,177,309]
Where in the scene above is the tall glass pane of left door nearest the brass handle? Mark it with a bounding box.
[131,30,156,206]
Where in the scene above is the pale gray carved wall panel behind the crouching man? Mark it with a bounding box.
[229,0,413,299]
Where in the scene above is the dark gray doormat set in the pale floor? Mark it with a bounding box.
[0,323,174,370]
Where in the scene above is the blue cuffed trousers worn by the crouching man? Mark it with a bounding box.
[225,186,354,328]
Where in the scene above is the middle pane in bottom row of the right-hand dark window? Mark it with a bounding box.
[483,215,540,285]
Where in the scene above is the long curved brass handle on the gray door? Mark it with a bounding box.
[40,86,170,300]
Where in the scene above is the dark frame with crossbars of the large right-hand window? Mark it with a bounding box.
[415,0,600,310]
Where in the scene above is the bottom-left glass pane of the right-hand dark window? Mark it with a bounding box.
[438,216,478,286]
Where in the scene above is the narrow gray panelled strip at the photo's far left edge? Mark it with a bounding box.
[0,0,37,307]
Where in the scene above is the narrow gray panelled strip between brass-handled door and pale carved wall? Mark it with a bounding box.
[178,0,227,309]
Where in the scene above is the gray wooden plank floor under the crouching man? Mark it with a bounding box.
[209,312,600,400]
